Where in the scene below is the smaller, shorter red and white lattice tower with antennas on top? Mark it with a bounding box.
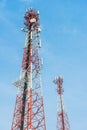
[54,77,70,130]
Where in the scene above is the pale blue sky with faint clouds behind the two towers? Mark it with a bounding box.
[0,0,87,130]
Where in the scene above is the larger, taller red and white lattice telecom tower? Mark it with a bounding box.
[11,9,46,130]
